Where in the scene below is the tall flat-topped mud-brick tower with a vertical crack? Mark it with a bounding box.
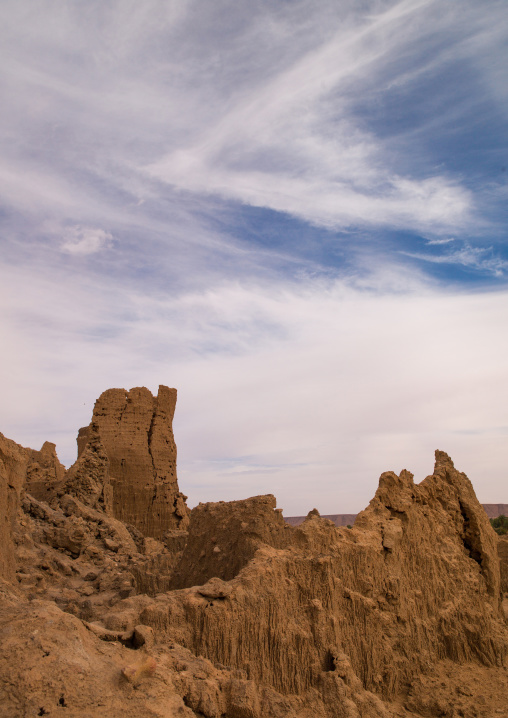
[78,386,189,538]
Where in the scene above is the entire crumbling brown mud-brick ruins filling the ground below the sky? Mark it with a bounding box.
[0,386,508,718]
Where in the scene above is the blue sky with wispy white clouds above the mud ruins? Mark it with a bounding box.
[0,0,508,516]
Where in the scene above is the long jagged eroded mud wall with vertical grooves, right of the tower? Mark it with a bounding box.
[123,452,507,698]
